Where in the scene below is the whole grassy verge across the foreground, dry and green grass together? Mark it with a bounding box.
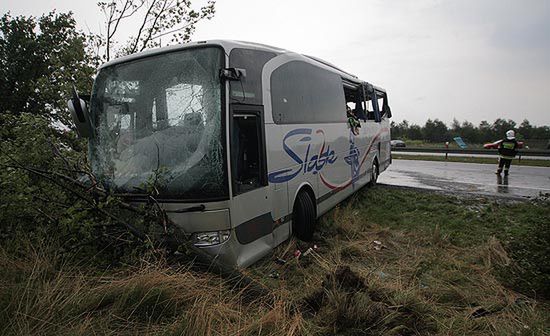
[0,186,550,335]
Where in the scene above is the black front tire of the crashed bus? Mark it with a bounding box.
[292,191,315,241]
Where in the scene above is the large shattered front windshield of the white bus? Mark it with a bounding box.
[91,48,227,199]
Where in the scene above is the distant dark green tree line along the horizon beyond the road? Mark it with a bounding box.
[391,118,550,144]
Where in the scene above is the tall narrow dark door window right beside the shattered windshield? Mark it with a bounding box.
[231,114,263,194]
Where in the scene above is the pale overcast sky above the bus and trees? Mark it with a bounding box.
[0,0,550,125]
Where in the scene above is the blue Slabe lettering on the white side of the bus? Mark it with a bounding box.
[268,128,338,183]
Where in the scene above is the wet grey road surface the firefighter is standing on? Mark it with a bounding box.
[378,158,550,197]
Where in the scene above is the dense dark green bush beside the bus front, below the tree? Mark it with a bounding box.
[0,113,157,263]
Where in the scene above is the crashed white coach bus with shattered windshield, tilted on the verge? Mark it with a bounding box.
[69,40,391,267]
